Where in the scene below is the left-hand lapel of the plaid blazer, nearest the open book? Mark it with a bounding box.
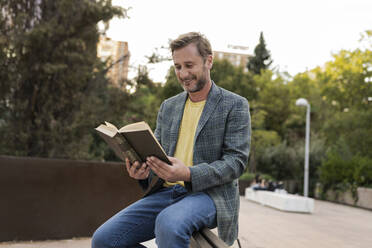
[169,91,187,156]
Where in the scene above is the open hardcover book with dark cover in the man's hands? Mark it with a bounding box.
[96,121,172,196]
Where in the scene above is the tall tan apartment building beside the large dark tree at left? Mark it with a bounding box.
[97,35,129,86]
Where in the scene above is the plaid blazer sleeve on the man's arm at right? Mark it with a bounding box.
[187,98,251,192]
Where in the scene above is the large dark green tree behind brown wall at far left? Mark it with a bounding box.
[0,0,125,158]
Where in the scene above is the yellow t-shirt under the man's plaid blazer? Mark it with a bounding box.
[164,98,206,187]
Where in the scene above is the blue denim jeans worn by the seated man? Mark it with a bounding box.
[92,185,217,248]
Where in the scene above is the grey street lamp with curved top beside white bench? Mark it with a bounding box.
[296,98,310,197]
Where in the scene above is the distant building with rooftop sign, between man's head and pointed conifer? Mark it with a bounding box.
[213,45,251,69]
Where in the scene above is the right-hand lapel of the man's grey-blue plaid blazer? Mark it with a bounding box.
[194,81,221,141]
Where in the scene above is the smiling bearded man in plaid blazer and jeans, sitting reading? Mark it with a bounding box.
[92,33,250,248]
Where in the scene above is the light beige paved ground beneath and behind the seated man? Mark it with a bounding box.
[0,197,372,248]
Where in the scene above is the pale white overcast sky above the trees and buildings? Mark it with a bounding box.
[107,0,372,82]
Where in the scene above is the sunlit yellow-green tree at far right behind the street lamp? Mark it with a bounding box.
[287,44,372,159]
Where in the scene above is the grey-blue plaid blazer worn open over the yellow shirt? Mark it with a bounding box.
[155,82,251,245]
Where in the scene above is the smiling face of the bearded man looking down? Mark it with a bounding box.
[173,44,212,93]
